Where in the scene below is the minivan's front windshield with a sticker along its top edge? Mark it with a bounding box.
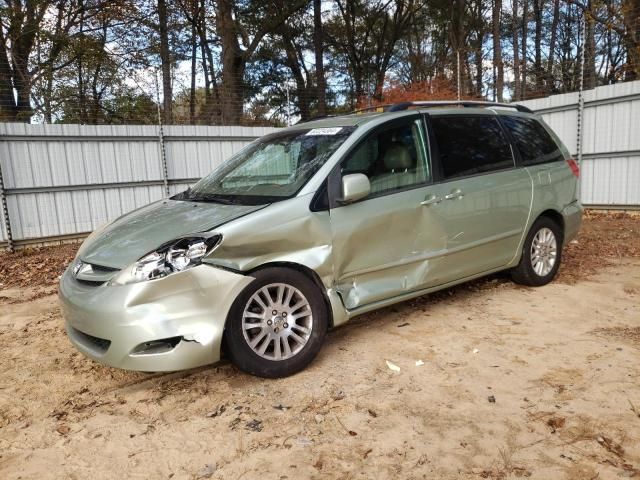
[173,127,355,205]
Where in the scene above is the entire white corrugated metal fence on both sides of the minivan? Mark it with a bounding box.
[0,81,640,245]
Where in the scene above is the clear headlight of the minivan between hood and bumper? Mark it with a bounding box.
[109,235,221,285]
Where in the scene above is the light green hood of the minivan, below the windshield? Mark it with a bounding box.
[79,200,264,269]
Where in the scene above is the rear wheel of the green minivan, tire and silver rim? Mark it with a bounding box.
[511,216,563,287]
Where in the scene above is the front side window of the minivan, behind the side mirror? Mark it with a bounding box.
[341,119,431,195]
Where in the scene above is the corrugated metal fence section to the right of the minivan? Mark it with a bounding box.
[519,81,640,207]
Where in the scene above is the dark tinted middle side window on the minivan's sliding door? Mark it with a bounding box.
[431,115,514,180]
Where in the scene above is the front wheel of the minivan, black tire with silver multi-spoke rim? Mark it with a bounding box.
[225,267,329,378]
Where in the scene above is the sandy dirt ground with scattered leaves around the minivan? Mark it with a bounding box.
[0,215,640,480]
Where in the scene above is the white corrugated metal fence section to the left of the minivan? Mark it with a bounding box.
[0,123,277,241]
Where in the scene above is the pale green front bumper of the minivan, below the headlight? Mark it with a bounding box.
[59,264,253,372]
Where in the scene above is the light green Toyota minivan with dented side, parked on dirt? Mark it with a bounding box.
[60,102,582,377]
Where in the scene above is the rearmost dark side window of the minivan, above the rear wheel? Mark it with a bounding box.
[501,116,564,165]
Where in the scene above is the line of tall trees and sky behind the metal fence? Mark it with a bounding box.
[0,0,640,125]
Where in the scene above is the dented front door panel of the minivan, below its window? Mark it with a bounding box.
[330,186,446,310]
